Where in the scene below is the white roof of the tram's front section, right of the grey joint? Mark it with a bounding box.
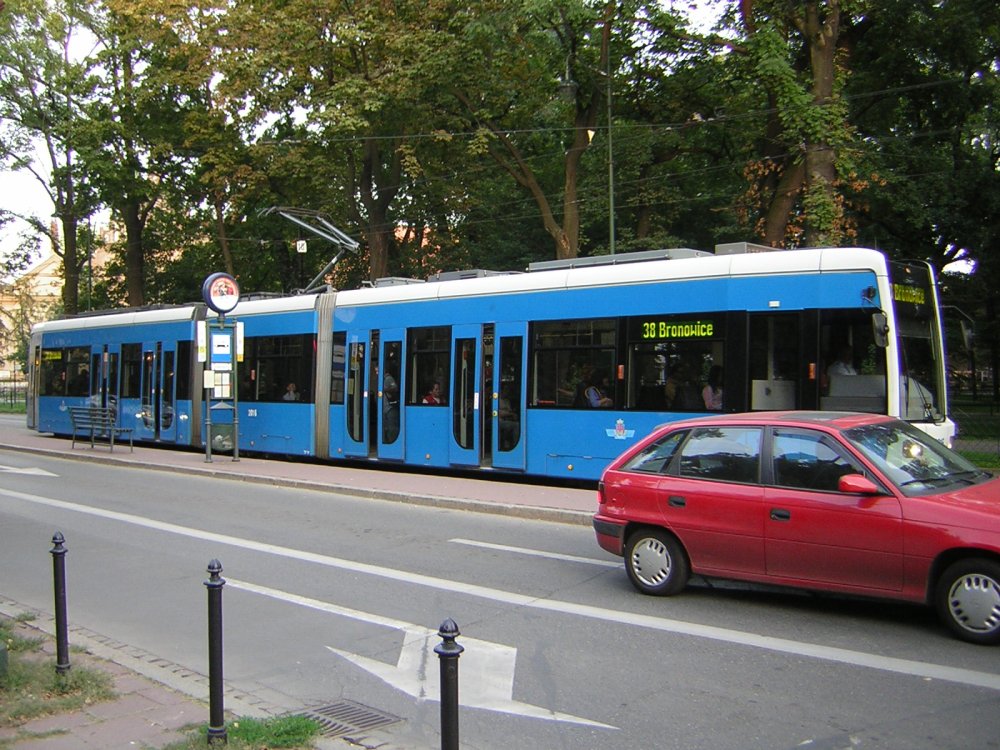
[337,247,887,307]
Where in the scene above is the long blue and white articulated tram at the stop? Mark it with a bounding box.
[28,244,954,479]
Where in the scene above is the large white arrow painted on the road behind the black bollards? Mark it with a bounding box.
[226,579,617,729]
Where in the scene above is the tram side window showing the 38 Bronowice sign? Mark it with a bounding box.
[627,315,725,411]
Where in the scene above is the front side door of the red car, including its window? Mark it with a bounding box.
[765,428,903,591]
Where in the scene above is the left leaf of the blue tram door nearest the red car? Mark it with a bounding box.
[448,325,484,466]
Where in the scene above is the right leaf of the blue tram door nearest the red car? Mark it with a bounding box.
[487,323,528,469]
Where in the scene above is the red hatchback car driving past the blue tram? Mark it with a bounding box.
[594,412,1000,644]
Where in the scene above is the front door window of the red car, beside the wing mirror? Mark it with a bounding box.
[771,429,865,492]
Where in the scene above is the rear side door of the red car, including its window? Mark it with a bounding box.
[660,426,764,577]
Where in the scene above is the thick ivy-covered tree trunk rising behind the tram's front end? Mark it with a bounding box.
[737,0,863,247]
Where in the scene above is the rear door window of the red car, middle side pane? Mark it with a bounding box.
[680,427,761,482]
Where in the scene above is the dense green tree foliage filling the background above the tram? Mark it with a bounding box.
[0,0,1000,320]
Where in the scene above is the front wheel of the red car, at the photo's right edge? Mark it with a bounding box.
[934,558,1000,645]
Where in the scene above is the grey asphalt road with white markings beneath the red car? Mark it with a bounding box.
[0,452,1000,750]
